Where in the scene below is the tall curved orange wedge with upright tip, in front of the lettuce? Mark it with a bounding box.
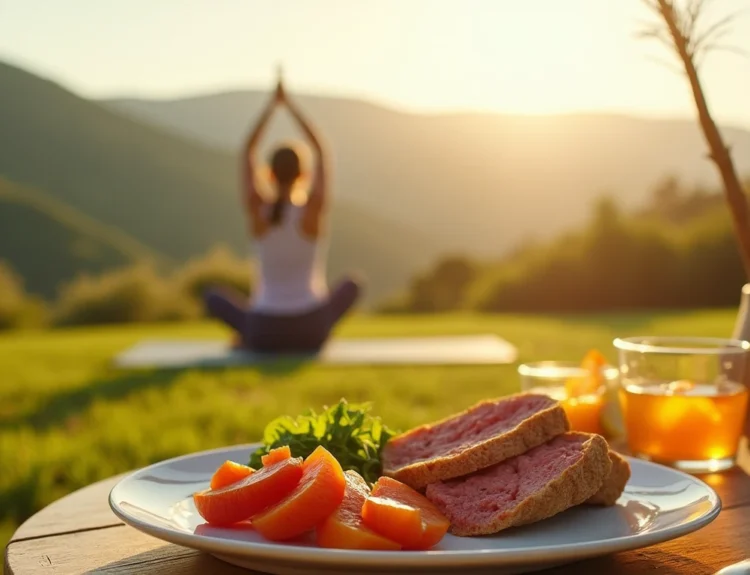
[251,446,346,541]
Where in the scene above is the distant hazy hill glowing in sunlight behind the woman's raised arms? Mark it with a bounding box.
[104,91,750,253]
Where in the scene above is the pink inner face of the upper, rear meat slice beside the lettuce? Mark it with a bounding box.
[387,395,555,468]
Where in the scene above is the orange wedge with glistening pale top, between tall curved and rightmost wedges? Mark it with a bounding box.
[315,471,401,551]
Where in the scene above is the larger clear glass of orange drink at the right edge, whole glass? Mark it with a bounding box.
[614,337,750,473]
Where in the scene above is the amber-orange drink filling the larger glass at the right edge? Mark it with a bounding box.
[620,382,748,462]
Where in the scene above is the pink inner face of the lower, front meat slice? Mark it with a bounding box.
[426,434,588,526]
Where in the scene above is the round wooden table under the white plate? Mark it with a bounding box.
[5,442,750,575]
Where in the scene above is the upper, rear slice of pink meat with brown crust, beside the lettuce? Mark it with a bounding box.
[382,393,570,490]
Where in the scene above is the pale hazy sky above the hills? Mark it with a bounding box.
[0,0,750,127]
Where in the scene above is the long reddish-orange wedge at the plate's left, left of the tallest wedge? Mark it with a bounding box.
[193,457,303,526]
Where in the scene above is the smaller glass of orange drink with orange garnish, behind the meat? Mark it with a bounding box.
[518,361,617,435]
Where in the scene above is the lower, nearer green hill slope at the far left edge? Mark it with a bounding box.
[0,178,168,298]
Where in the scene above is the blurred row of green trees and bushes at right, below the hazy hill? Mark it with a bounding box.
[381,178,750,313]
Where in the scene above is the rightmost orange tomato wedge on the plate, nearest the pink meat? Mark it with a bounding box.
[362,476,450,549]
